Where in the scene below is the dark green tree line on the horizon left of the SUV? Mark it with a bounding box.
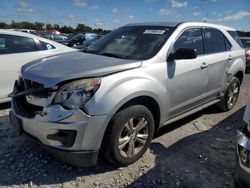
[0,21,110,35]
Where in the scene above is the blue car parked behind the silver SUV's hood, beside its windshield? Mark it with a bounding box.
[66,33,102,49]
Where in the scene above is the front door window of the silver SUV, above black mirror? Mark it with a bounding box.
[173,28,203,55]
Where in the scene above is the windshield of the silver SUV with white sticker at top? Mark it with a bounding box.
[84,26,174,60]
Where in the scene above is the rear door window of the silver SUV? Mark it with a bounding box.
[204,28,230,54]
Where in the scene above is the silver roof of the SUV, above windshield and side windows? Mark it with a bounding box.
[125,22,235,31]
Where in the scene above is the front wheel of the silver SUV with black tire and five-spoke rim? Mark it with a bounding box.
[101,105,154,166]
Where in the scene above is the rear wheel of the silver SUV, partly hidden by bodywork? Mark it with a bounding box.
[217,77,240,112]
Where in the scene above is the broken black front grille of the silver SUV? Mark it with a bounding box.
[12,78,50,118]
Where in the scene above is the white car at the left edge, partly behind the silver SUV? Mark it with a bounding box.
[0,29,75,103]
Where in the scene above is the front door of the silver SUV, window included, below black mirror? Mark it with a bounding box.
[167,28,209,118]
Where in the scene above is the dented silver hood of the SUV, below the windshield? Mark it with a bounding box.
[21,51,142,88]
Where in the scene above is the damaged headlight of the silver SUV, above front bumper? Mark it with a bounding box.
[54,78,101,108]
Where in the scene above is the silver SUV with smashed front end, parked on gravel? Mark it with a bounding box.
[10,22,245,166]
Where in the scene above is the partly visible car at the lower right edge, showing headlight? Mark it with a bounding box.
[235,99,250,187]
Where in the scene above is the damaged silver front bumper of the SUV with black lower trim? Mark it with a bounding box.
[10,99,108,166]
